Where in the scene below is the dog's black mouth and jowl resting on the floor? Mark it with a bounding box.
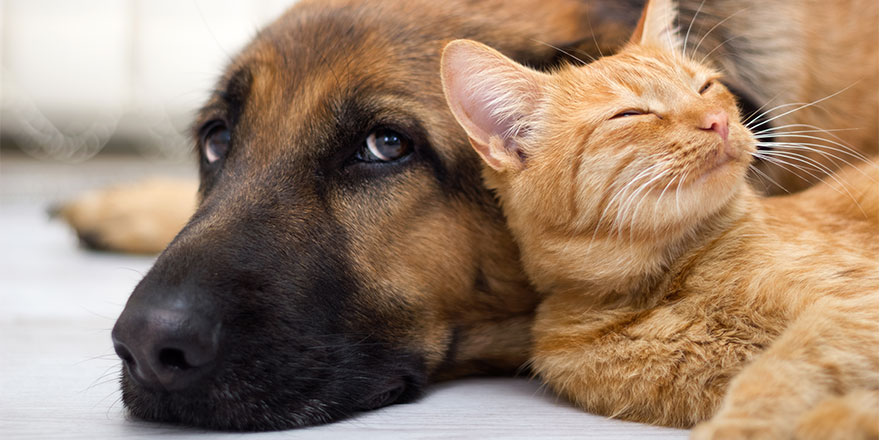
[117,306,427,431]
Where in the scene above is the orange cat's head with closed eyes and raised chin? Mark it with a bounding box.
[441,0,755,242]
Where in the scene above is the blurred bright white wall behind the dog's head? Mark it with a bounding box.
[0,0,293,160]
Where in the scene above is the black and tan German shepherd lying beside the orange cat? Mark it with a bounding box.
[82,0,877,430]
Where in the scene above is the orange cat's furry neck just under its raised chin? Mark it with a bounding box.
[511,185,760,306]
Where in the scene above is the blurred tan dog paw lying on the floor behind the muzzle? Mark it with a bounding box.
[51,179,198,254]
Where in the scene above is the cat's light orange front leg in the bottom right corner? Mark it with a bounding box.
[691,293,878,440]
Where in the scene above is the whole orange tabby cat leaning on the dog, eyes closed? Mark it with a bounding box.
[442,0,878,439]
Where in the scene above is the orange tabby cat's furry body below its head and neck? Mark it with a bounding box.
[533,166,878,432]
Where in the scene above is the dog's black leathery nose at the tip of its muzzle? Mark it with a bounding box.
[112,303,220,391]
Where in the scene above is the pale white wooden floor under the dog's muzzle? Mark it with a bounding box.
[0,150,687,440]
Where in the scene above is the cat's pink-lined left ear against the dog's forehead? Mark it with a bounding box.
[440,40,544,171]
